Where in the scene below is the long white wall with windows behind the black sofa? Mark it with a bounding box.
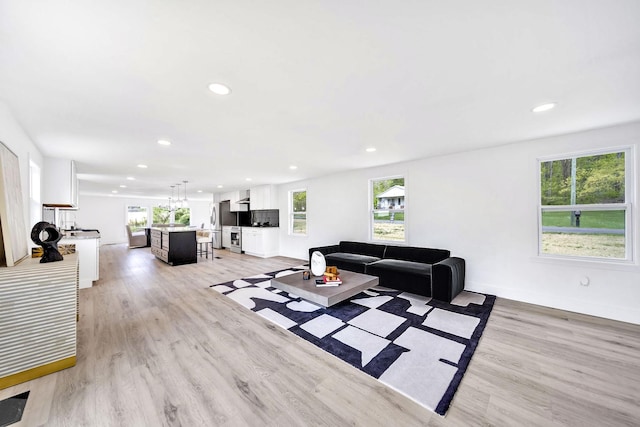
[279,123,640,324]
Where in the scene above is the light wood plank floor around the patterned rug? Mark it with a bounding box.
[0,245,640,426]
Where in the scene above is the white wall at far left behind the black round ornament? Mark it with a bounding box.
[0,101,43,247]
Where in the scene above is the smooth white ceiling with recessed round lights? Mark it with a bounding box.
[0,0,640,201]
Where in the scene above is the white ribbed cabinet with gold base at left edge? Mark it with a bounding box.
[0,254,78,389]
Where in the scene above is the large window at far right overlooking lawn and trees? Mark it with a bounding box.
[538,149,633,261]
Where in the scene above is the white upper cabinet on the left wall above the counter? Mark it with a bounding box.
[42,157,78,208]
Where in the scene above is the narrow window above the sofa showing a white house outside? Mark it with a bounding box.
[370,177,406,242]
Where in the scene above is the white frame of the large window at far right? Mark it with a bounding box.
[536,146,637,264]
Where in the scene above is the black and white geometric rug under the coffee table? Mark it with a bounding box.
[211,266,495,415]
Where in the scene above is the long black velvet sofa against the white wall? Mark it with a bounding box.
[309,241,465,302]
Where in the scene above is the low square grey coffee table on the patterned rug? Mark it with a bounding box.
[271,271,379,307]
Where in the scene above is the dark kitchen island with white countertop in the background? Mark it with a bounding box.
[151,227,198,265]
